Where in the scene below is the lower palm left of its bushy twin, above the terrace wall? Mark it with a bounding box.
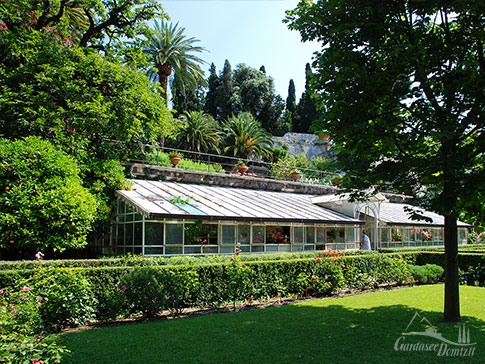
[177,111,221,160]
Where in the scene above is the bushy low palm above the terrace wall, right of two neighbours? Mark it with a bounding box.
[223,112,273,159]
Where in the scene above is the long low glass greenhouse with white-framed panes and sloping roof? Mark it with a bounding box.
[112,172,470,256]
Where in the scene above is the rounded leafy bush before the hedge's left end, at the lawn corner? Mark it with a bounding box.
[25,268,97,331]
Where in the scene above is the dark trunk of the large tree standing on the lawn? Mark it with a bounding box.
[444,212,461,322]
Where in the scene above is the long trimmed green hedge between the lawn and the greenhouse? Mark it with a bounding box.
[0,253,413,320]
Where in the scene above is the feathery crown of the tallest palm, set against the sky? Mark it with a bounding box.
[143,20,206,100]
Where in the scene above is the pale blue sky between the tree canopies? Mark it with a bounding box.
[162,0,319,100]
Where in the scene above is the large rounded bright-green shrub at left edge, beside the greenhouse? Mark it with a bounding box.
[0,137,97,251]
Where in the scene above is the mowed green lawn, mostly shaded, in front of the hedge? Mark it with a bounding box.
[59,285,485,364]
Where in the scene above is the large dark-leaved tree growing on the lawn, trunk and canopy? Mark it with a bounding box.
[286,0,485,321]
